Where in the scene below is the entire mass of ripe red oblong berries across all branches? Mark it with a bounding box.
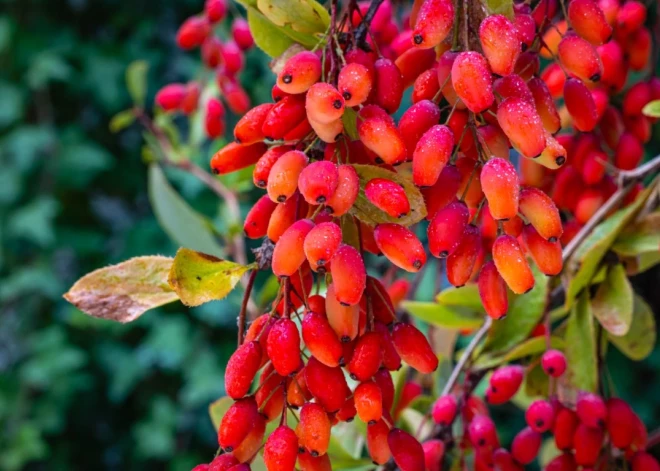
[147,0,660,471]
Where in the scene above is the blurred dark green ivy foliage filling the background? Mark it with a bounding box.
[0,0,660,471]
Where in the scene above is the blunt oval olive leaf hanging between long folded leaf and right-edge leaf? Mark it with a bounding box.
[591,264,633,336]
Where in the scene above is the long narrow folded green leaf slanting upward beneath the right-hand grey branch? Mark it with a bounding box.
[564,185,654,307]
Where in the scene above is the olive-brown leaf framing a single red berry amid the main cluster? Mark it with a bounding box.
[350,164,426,226]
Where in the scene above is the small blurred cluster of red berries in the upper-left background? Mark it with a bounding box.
[156,0,254,139]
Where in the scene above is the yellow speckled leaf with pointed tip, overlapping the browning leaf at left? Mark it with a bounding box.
[167,248,252,306]
